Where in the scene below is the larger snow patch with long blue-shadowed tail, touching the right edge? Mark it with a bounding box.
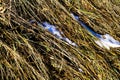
[71,13,120,50]
